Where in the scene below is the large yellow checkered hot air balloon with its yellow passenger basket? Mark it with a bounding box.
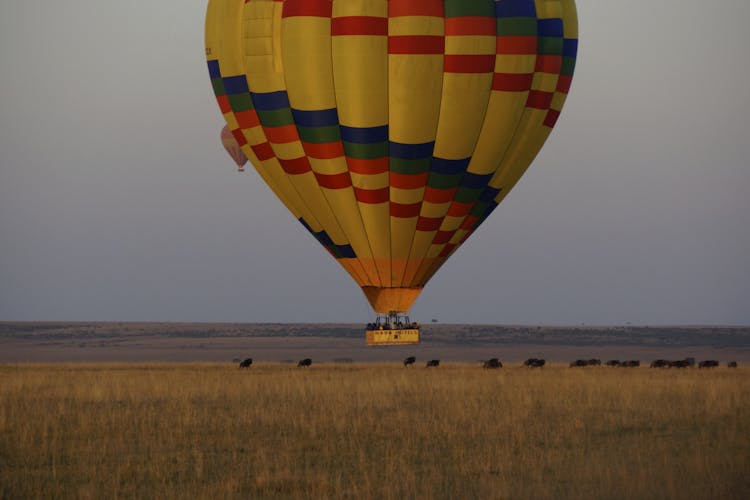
[206,0,578,345]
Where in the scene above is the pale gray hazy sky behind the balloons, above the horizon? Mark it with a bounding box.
[0,0,750,325]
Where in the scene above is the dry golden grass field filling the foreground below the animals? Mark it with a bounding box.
[0,364,750,499]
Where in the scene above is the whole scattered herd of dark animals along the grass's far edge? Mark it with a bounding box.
[234,356,737,369]
